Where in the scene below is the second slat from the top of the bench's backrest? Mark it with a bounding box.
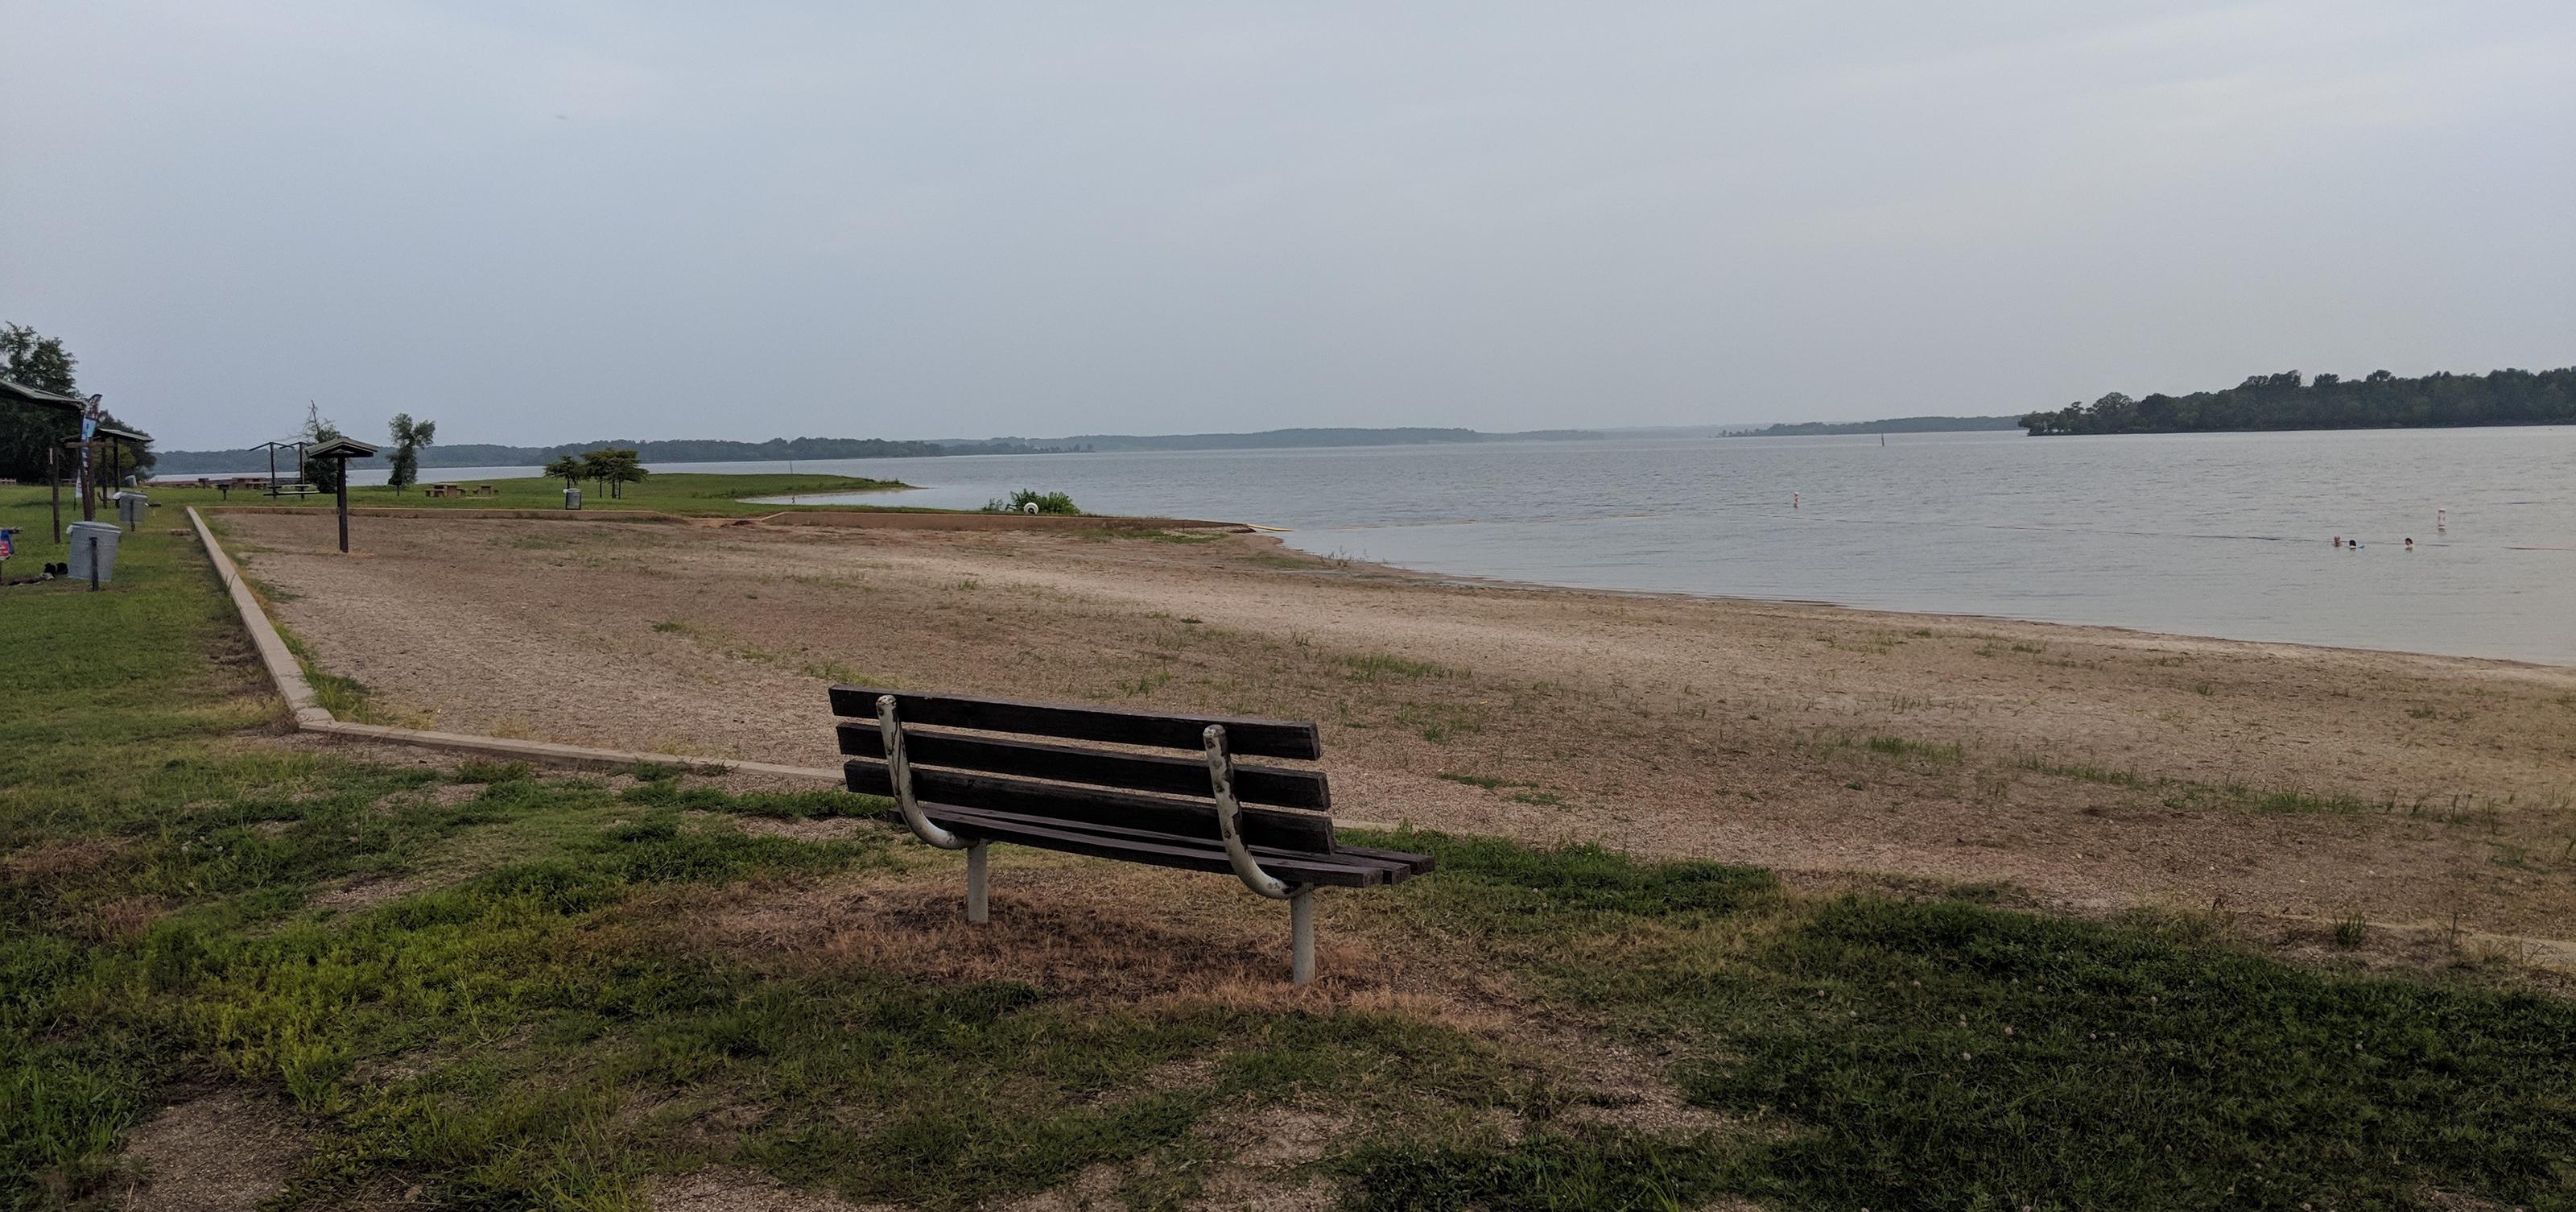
[840,719,1331,807]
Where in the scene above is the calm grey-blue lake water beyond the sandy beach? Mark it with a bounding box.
[348,425,2576,665]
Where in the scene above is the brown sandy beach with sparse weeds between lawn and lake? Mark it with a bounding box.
[219,513,2576,952]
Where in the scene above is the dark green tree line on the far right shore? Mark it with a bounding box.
[2022,366,2576,436]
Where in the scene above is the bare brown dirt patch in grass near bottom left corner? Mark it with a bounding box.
[121,1088,304,1212]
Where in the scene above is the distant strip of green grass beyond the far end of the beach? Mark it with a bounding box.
[130,467,910,519]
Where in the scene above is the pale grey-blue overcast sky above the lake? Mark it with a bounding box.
[0,0,2576,449]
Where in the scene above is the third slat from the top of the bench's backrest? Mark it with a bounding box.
[842,758,1335,854]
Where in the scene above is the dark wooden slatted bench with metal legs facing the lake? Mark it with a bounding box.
[832,686,1432,985]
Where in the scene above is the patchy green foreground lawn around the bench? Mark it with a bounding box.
[0,487,2576,1210]
